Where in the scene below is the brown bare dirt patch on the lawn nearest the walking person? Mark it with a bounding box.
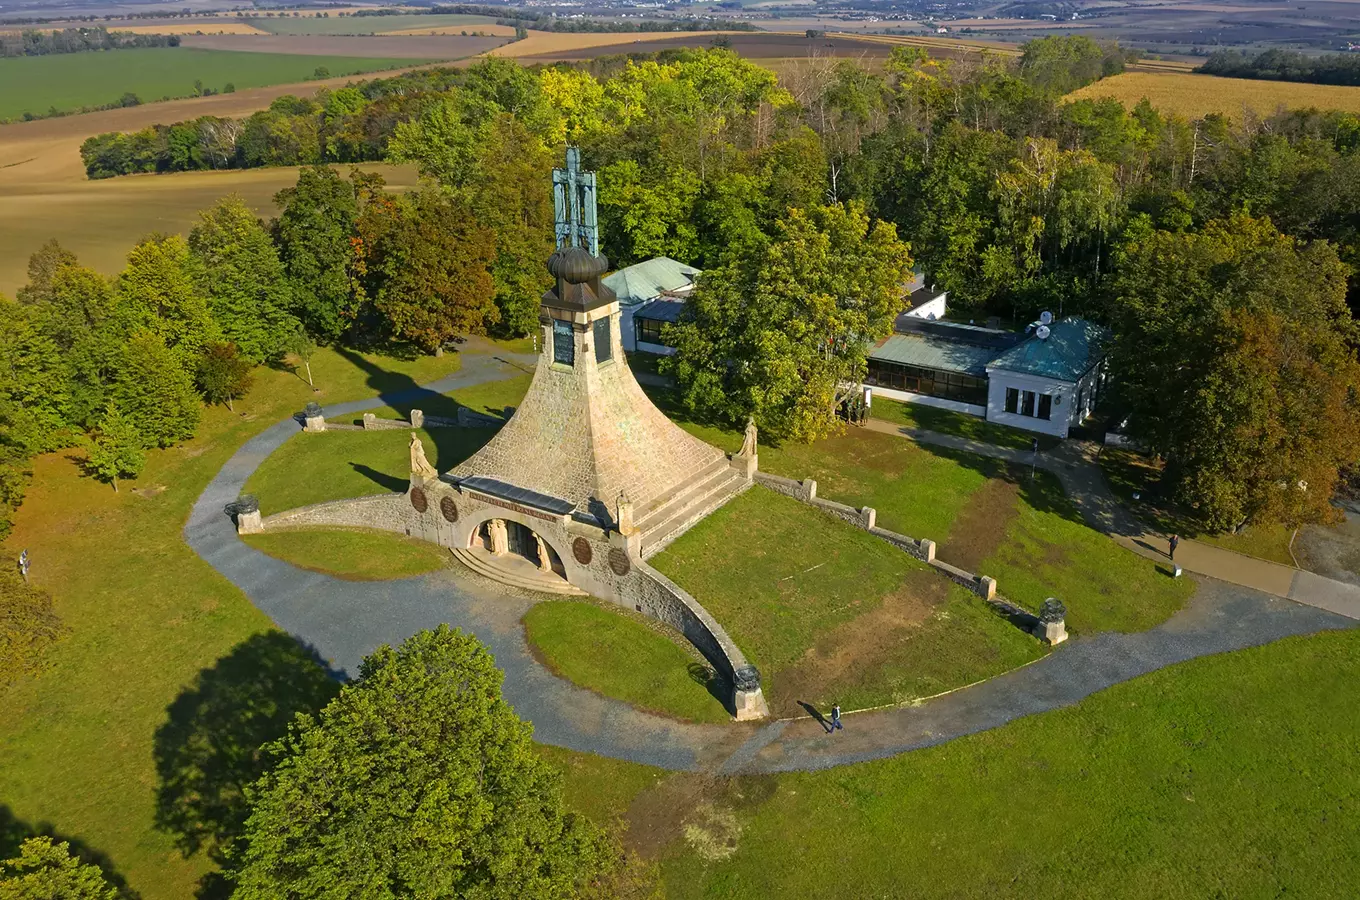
[767,571,949,716]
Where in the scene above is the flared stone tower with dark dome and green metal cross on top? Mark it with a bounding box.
[446,148,745,553]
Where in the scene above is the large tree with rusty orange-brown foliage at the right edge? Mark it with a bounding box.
[1111,216,1360,530]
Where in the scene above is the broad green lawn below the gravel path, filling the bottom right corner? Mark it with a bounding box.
[544,629,1360,900]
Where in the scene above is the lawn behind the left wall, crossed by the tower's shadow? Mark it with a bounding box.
[246,375,529,515]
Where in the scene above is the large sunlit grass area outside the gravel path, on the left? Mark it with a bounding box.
[0,342,458,900]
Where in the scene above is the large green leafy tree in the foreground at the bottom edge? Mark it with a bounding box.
[231,625,619,900]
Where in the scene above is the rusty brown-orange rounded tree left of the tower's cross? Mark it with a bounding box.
[352,189,499,353]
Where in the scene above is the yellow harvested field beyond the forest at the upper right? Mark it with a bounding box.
[1068,72,1360,118]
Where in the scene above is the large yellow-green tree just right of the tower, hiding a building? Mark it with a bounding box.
[665,204,911,440]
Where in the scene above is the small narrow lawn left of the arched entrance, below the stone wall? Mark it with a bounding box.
[243,529,449,581]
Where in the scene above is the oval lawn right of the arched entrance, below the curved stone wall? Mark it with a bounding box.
[524,600,732,723]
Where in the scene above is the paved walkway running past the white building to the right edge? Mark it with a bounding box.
[866,419,1360,619]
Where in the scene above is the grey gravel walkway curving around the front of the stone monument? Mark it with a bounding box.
[184,353,1356,774]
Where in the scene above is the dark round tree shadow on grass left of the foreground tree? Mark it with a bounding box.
[152,631,340,897]
